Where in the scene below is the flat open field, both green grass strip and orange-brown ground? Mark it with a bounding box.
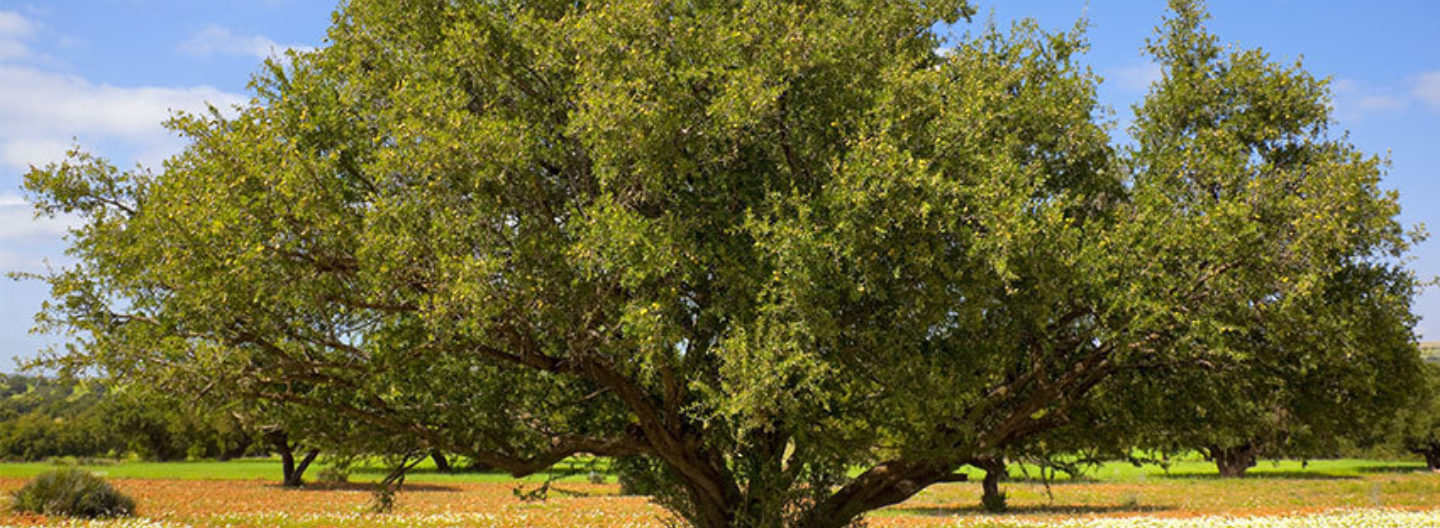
[0,460,1440,528]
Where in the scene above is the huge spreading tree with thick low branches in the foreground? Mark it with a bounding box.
[26,0,1410,527]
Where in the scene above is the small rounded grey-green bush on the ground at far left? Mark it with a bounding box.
[12,468,135,518]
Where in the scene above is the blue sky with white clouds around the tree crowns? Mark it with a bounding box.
[0,0,1440,371]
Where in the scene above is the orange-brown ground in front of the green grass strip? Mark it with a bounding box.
[0,472,1440,527]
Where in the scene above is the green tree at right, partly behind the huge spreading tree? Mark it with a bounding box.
[1082,1,1420,471]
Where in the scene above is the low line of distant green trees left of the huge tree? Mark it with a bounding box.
[0,374,487,486]
